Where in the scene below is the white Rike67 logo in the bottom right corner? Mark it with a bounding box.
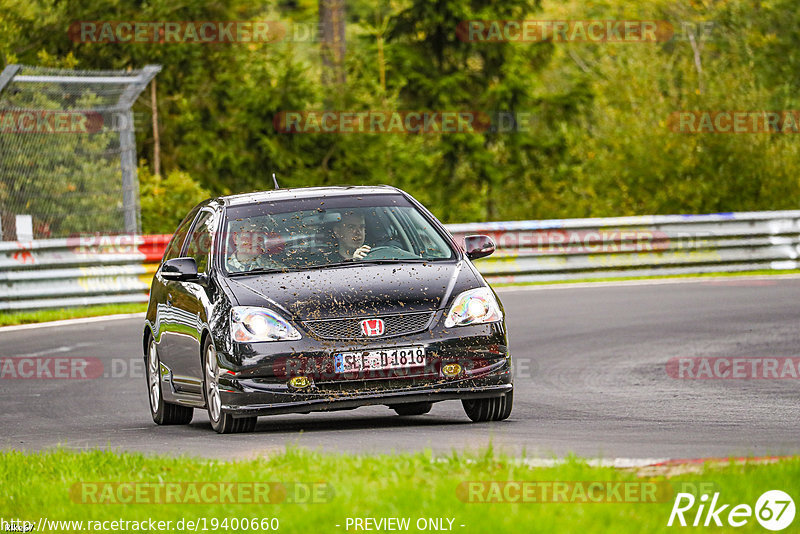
[667,490,795,531]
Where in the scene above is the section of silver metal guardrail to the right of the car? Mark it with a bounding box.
[448,210,800,283]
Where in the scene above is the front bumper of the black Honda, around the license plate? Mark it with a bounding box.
[218,322,513,417]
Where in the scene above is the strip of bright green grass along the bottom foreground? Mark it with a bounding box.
[0,450,800,534]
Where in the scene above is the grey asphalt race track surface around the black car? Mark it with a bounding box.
[0,278,800,458]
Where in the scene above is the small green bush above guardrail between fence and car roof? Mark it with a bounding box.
[139,165,211,234]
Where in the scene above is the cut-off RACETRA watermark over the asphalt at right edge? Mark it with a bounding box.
[666,357,800,380]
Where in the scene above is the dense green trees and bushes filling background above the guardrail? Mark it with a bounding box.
[0,0,800,224]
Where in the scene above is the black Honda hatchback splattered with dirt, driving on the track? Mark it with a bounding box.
[143,186,513,433]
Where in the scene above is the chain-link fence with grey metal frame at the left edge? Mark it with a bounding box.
[0,65,161,241]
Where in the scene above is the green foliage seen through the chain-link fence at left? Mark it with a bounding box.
[0,53,131,238]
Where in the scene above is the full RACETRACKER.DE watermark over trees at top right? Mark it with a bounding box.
[456,20,675,43]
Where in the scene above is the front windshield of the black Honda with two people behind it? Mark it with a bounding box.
[220,194,454,274]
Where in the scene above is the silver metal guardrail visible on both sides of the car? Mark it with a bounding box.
[0,210,800,311]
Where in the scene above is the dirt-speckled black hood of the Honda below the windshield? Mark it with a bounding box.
[222,261,484,320]
